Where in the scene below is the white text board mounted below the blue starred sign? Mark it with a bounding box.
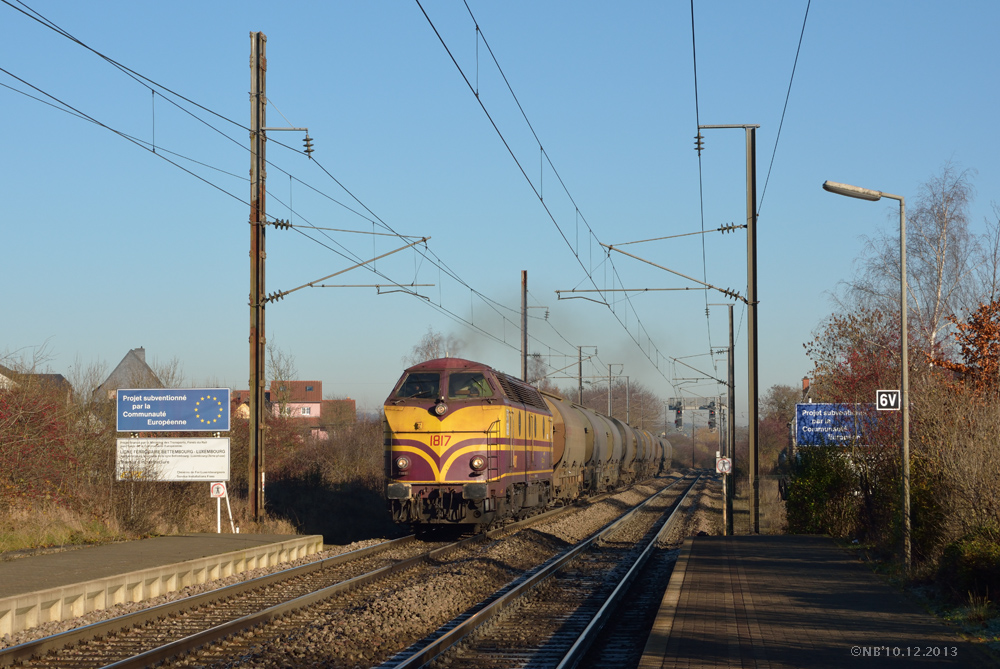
[115,437,229,482]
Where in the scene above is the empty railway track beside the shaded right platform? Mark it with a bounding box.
[379,476,701,669]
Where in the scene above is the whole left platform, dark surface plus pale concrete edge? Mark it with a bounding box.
[0,534,323,636]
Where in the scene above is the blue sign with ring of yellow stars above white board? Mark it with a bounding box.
[117,388,229,432]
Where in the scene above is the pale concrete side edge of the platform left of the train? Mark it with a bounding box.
[0,534,323,635]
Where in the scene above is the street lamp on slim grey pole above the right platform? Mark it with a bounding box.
[823,181,910,570]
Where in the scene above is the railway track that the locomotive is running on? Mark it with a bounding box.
[0,486,640,669]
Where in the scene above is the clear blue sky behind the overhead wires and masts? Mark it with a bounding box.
[0,0,1000,418]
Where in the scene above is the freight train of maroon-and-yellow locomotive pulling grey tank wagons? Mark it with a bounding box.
[383,358,672,529]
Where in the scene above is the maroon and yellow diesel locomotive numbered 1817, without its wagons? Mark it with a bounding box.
[384,358,554,524]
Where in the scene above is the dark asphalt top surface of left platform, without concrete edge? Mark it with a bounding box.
[0,534,312,599]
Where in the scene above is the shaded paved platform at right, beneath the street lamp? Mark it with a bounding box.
[639,535,998,669]
